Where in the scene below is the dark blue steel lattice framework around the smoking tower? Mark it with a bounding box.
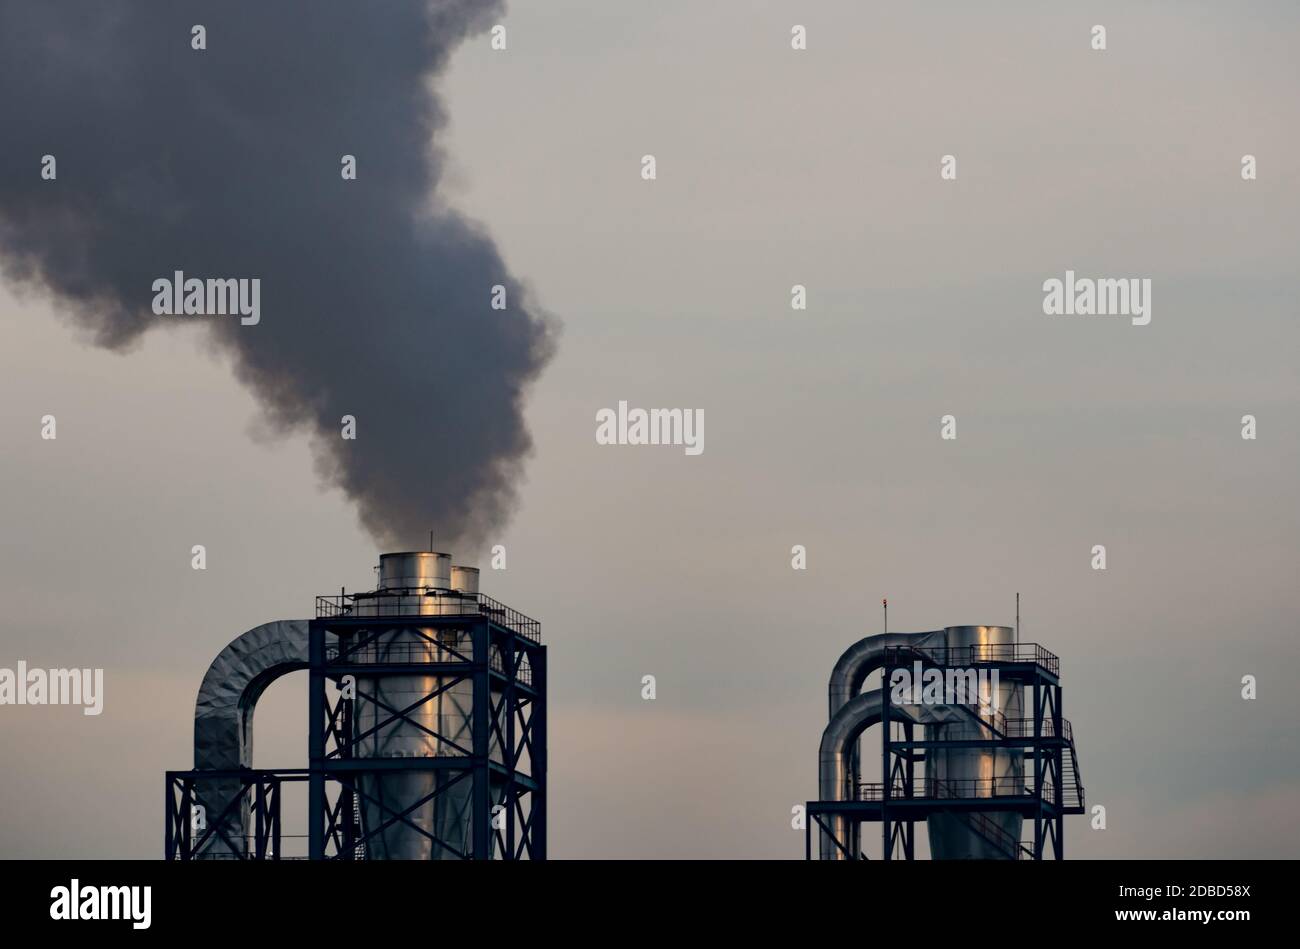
[166,595,546,861]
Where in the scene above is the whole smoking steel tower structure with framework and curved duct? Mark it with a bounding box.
[166,551,546,859]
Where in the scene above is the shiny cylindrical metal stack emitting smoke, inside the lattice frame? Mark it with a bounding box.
[354,551,483,859]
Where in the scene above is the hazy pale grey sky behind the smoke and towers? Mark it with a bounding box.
[0,0,1300,858]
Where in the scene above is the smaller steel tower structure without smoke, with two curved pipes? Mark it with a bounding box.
[807,625,1083,859]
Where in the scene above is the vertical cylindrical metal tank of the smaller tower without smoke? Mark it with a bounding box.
[926,627,1024,859]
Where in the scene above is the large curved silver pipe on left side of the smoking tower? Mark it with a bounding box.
[194,620,308,857]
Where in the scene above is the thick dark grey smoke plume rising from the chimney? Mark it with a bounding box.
[0,0,554,549]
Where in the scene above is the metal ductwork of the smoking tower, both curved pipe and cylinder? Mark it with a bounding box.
[194,551,501,859]
